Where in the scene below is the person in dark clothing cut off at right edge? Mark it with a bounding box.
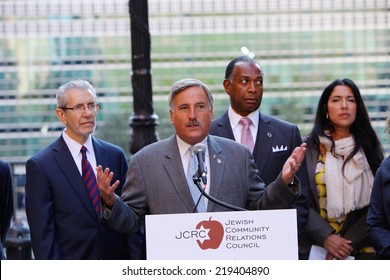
[367,112,390,260]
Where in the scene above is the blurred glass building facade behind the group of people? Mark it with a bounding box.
[0,0,390,162]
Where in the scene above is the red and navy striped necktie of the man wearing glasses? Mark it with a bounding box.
[80,146,100,218]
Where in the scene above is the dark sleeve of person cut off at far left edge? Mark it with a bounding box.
[0,160,14,259]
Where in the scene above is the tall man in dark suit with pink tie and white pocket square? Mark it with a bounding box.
[210,56,309,244]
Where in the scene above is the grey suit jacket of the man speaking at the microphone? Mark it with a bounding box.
[104,136,297,232]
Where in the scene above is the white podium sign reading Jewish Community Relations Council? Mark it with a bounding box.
[146,209,298,260]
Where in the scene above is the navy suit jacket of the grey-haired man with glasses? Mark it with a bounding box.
[26,136,142,259]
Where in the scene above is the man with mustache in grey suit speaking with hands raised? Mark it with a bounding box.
[97,79,306,232]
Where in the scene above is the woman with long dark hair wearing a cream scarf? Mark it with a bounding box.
[300,79,384,259]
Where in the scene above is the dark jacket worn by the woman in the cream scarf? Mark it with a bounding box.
[299,139,370,257]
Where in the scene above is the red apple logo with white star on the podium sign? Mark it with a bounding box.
[196,217,224,250]
